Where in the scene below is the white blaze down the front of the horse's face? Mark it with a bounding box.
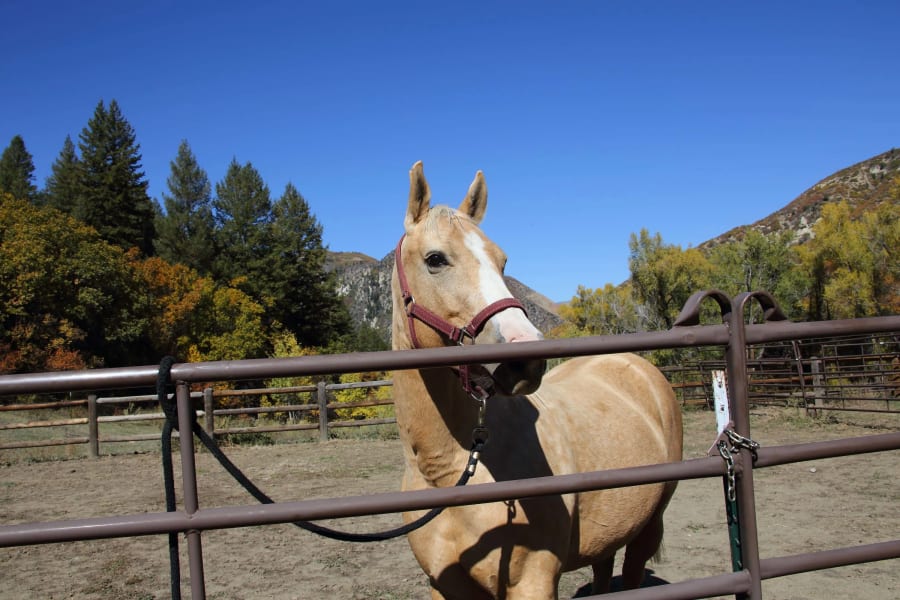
[465,231,544,342]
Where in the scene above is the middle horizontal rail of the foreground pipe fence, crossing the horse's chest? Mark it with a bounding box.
[0,432,900,547]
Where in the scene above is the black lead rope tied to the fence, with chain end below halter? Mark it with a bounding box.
[156,356,487,600]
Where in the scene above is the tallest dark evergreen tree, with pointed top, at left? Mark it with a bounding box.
[75,100,155,255]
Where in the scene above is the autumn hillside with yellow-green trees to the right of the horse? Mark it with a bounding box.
[556,150,900,358]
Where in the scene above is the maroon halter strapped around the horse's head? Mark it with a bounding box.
[394,234,528,401]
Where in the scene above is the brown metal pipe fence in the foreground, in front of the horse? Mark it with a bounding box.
[0,291,900,599]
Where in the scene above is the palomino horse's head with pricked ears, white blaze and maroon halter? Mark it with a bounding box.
[393,162,545,395]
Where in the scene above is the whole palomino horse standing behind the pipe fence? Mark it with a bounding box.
[392,162,682,600]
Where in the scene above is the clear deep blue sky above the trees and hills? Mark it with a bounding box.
[0,0,900,300]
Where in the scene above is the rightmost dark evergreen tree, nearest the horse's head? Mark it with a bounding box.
[268,183,350,346]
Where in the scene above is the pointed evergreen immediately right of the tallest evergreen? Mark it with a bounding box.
[154,140,216,275]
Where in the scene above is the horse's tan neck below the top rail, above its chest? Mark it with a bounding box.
[394,360,478,487]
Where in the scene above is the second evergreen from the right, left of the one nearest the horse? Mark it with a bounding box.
[213,159,272,296]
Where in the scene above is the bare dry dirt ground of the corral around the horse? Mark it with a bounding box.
[0,409,900,600]
